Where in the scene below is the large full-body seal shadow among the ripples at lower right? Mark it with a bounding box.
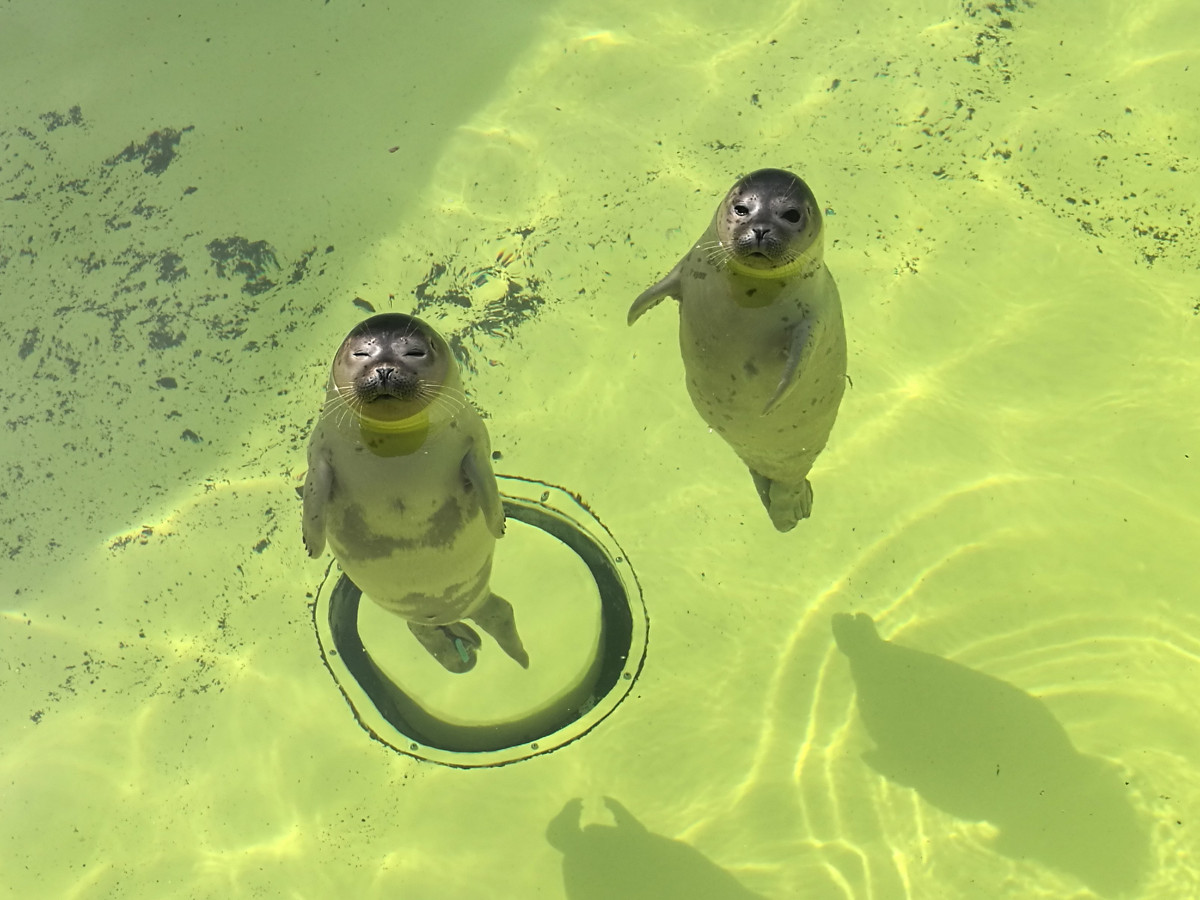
[833,613,1148,896]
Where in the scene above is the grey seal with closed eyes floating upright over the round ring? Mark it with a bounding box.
[302,313,529,672]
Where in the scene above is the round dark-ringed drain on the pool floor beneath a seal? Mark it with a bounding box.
[313,475,649,768]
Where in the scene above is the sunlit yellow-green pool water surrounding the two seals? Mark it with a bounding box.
[0,0,1200,900]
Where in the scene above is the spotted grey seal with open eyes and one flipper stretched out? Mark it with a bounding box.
[629,169,846,532]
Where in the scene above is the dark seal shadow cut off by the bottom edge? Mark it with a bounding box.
[546,797,766,900]
